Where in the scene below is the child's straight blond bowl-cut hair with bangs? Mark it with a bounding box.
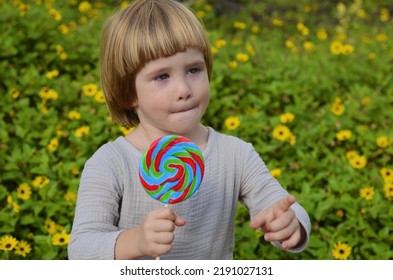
[100,0,213,127]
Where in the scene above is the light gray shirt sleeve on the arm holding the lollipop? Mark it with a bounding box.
[68,144,122,260]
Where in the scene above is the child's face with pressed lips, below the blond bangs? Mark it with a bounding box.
[134,48,210,135]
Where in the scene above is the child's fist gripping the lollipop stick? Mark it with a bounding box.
[139,207,186,257]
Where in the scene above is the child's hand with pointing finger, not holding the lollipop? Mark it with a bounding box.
[250,195,305,249]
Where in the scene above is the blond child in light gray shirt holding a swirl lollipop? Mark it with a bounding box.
[68,0,310,259]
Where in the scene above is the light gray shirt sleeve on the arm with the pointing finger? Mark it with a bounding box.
[240,144,311,252]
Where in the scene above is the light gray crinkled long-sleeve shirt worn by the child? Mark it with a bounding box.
[68,128,311,259]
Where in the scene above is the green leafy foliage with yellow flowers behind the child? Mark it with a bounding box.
[0,0,393,259]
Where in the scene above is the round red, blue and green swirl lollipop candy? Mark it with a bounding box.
[139,135,204,204]
